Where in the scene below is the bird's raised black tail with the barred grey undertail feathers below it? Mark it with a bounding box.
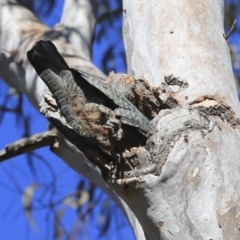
[27,41,83,123]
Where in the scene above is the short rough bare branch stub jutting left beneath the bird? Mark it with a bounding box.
[0,129,58,162]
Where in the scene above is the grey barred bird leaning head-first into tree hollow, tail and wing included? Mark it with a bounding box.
[27,41,150,135]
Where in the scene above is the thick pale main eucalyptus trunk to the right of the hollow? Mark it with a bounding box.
[117,0,240,239]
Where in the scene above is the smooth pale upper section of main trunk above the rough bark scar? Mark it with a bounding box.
[123,0,240,116]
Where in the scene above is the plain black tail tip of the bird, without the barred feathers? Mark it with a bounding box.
[27,40,69,75]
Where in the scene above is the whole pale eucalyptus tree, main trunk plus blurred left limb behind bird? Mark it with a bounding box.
[0,0,240,240]
